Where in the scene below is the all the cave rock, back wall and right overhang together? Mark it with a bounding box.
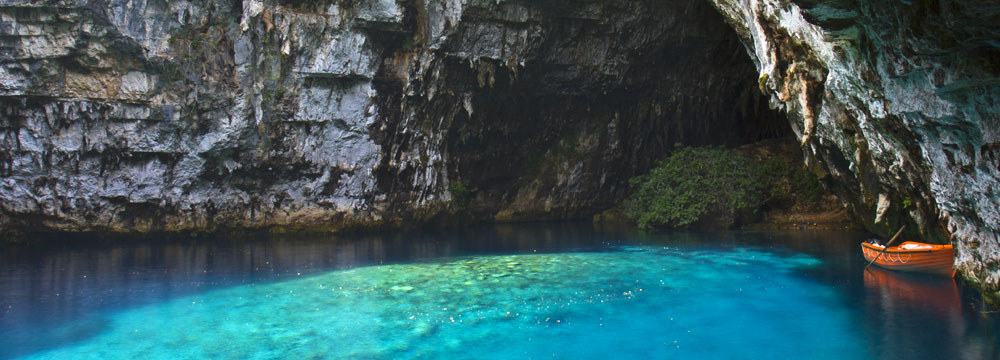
[0,0,1000,302]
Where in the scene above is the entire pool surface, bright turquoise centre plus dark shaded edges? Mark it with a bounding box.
[0,224,1000,359]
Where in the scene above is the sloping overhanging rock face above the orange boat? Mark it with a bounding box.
[713,0,1000,299]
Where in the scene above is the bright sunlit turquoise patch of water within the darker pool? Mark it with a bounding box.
[26,246,867,359]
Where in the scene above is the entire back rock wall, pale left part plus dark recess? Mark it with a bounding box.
[0,0,785,232]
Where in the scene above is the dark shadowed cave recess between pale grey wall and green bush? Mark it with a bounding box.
[372,0,791,221]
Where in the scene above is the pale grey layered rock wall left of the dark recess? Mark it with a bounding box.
[0,0,383,231]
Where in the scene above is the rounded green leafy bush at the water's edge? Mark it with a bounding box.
[625,147,822,230]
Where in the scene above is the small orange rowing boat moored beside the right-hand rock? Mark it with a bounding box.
[861,241,955,275]
